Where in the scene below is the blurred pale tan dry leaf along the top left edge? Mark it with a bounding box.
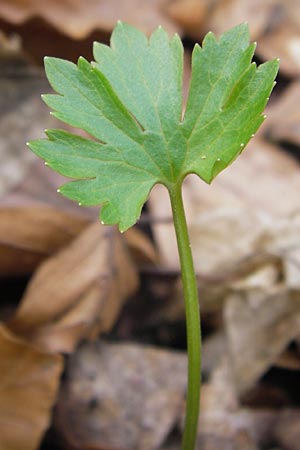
[0,0,176,39]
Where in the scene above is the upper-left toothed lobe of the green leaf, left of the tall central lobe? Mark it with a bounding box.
[43,58,142,144]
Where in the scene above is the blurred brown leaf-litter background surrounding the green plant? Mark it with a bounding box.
[0,0,300,450]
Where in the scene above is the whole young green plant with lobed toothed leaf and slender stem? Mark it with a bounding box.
[29,22,278,450]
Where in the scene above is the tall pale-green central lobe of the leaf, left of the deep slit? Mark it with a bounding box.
[94,23,183,138]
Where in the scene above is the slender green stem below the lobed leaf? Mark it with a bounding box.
[169,185,201,450]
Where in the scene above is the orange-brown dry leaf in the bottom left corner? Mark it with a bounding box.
[0,325,63,450]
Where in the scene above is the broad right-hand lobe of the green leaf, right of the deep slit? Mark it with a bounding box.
[183,24,278,183]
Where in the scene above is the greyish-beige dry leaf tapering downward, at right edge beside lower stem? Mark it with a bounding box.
[224,285,300,393]
